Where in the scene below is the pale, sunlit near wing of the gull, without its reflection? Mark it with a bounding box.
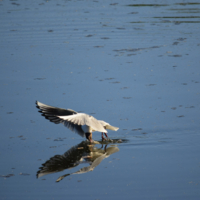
[58,113,107,133]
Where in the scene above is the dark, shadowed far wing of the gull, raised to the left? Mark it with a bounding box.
[36,101,85,137]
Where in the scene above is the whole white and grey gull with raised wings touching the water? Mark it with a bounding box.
[36,101,119,143]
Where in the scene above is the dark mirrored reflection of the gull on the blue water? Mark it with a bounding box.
[37,140,123,182]
